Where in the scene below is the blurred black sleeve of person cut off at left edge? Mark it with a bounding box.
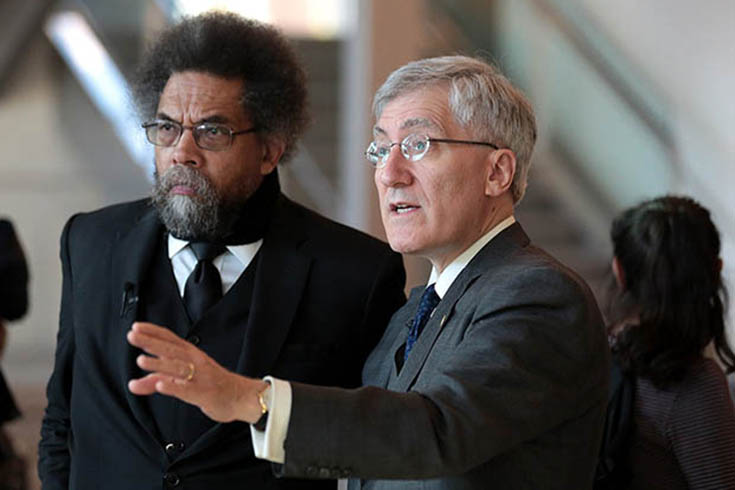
[0,220,28,320]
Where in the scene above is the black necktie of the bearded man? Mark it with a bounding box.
[184,242,227,323]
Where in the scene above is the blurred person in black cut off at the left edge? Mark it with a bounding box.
[0,219,28,490]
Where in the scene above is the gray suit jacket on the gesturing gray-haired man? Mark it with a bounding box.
[278,224,609,490]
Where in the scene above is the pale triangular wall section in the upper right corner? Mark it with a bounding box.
[575,0,735,156]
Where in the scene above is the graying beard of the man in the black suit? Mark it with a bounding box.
[151,165,224,241]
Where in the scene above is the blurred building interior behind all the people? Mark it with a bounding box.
[0,0,735,488]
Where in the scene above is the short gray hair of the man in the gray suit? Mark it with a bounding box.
[373,56,536,204]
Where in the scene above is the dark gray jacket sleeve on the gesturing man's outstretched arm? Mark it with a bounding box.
[279,266,608,479]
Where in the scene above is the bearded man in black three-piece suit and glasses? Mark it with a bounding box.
[39,14,405,490]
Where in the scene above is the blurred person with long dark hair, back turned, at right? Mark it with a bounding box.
[610,196,735,490]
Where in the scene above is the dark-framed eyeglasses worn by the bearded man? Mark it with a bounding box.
[143,119,258,151]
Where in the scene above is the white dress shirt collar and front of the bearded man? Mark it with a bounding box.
[168,235,263,298]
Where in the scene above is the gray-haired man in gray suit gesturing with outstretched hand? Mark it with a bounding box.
[128,56,608,490]
